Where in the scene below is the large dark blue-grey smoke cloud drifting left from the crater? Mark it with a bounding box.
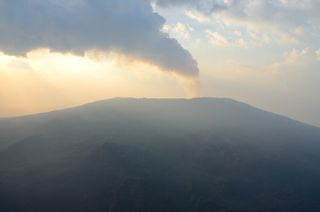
[0,0,198,76]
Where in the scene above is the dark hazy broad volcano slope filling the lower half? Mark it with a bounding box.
[0,98,320,212]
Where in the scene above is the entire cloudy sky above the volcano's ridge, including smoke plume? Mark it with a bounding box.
[0,0,320,126]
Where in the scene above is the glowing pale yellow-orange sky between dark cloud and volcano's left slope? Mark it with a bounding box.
[0,49,193,116]
